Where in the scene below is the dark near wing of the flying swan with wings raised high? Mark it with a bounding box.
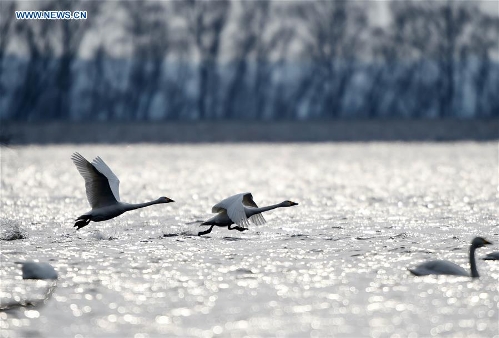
[71,153,117,209]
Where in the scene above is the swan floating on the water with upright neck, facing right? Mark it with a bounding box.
[409,237,492,277]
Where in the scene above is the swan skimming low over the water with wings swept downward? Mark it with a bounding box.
[198,192,298,236]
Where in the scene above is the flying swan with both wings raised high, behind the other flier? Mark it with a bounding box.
[71,153,174,230]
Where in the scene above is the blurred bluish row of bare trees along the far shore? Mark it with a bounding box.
[0,0,499,121]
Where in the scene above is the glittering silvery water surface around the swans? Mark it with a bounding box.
[0,142,499,337]
